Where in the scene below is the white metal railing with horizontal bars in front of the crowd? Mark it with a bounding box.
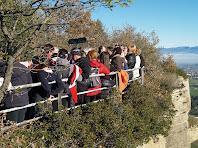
[0,67,144,131]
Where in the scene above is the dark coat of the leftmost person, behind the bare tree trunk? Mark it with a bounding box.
[2,62,32,108]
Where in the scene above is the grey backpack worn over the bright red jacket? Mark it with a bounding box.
[89,67,100,88]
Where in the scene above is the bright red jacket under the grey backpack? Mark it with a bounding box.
[85,60,110,96]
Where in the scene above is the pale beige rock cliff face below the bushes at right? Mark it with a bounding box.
[138,77,191,148]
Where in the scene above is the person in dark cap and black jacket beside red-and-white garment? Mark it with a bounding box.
[71,48,91,104]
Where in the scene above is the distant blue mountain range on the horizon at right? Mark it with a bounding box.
[160,46,198,54]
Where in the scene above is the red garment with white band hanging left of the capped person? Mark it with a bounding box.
[69,65,82,103]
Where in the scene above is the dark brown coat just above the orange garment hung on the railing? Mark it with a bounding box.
[110,54,124,71]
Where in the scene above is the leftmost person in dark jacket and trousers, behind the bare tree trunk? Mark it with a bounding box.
[2,62,32,123]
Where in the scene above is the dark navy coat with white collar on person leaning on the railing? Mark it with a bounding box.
[38,69,64,98]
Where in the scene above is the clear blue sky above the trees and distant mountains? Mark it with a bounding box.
[92,0,198,47]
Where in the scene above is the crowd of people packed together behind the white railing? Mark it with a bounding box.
[0,44,144,122]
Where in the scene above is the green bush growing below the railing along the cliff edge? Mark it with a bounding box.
[0,83,174,148]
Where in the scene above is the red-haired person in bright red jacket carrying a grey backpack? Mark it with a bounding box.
[85,50,110,101]
